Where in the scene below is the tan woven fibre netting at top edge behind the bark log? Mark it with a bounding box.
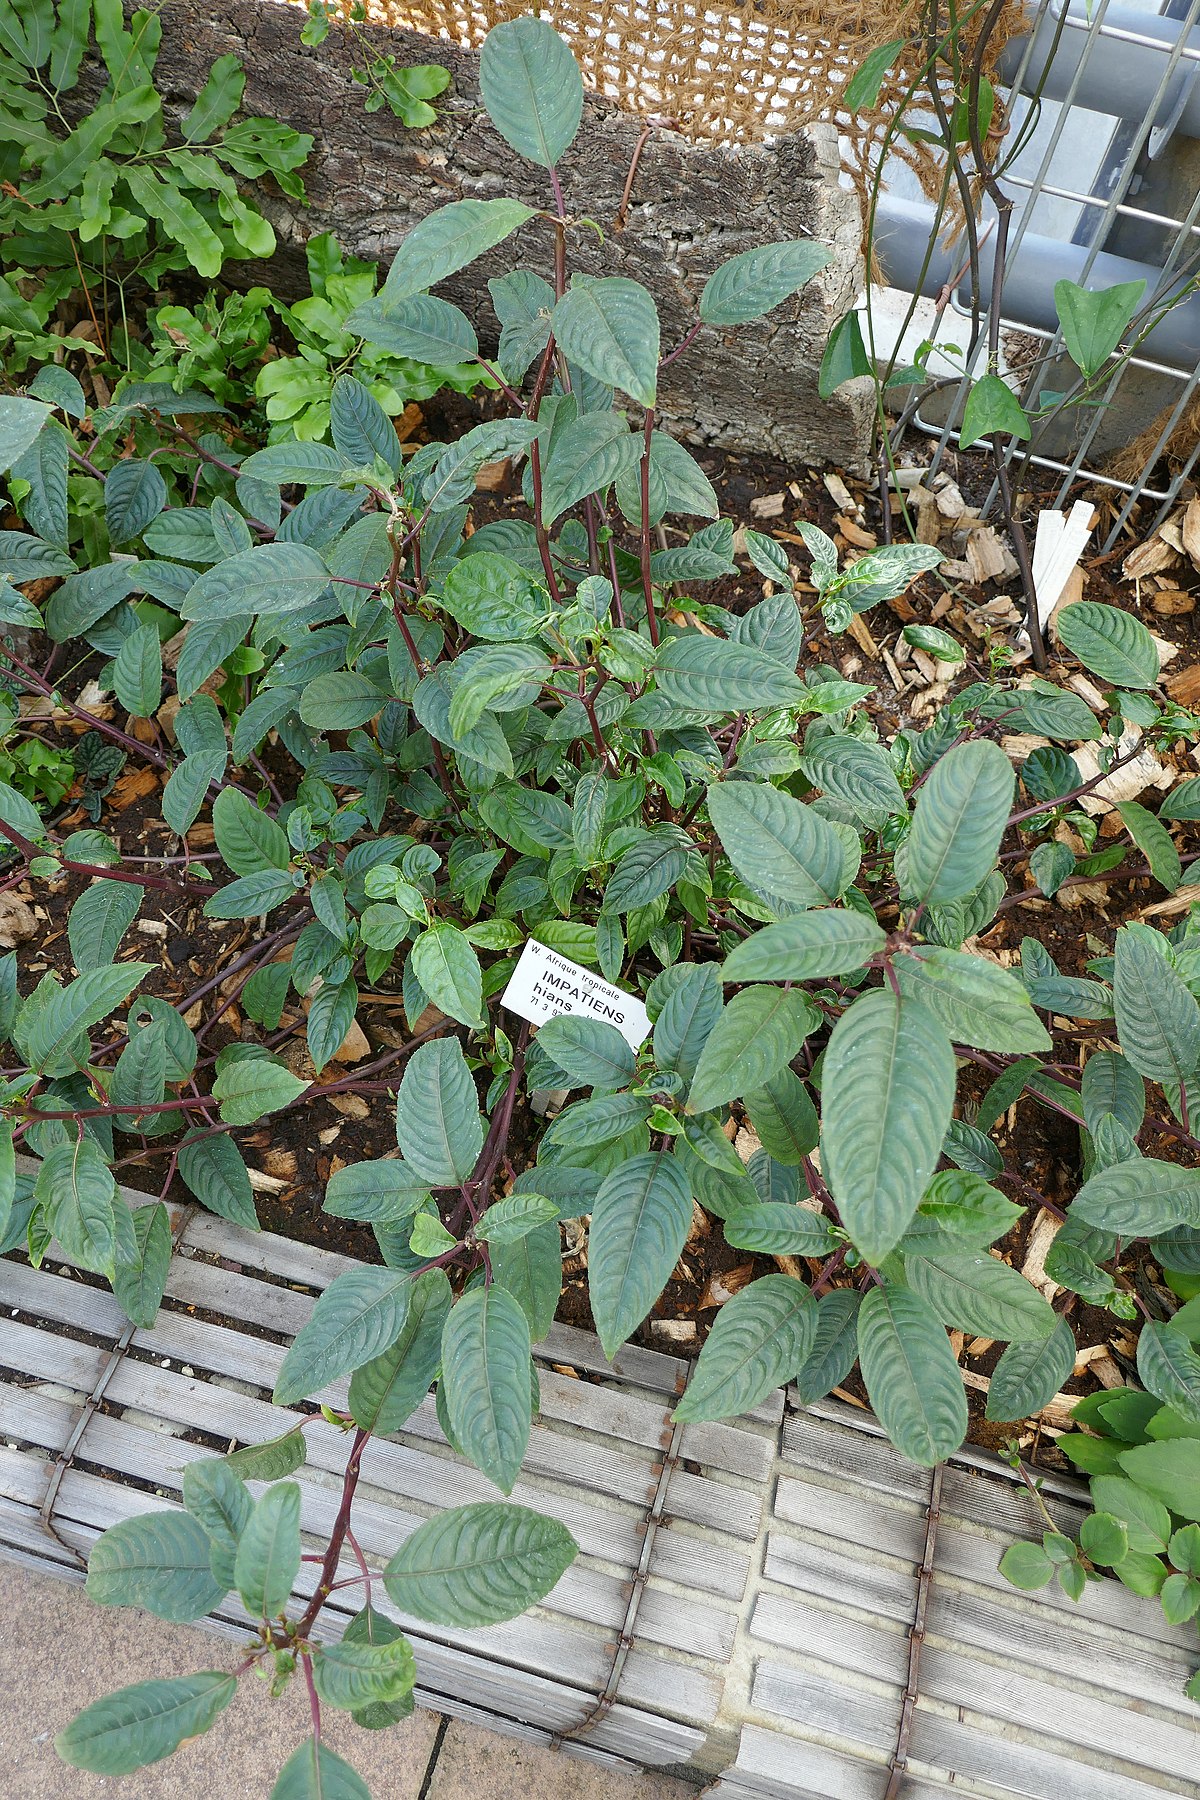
[322,0,1024,174]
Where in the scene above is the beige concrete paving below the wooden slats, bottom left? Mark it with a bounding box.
[0,1561,696,1800]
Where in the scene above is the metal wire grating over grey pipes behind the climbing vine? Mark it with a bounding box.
[876,0,1200,549]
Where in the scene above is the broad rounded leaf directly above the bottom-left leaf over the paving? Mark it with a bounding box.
[88,1512,225,1624]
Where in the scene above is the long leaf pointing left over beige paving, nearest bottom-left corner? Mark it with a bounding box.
[54,1669,237,1795]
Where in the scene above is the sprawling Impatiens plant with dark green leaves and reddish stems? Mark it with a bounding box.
[0,20,1200,1800]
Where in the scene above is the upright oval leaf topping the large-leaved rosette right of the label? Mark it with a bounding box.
[898,738,1016,905]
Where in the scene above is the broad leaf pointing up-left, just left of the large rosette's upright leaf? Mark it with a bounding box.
[709,781,855,907]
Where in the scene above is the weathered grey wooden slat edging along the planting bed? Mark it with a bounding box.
[0,1173,1200,1800]
